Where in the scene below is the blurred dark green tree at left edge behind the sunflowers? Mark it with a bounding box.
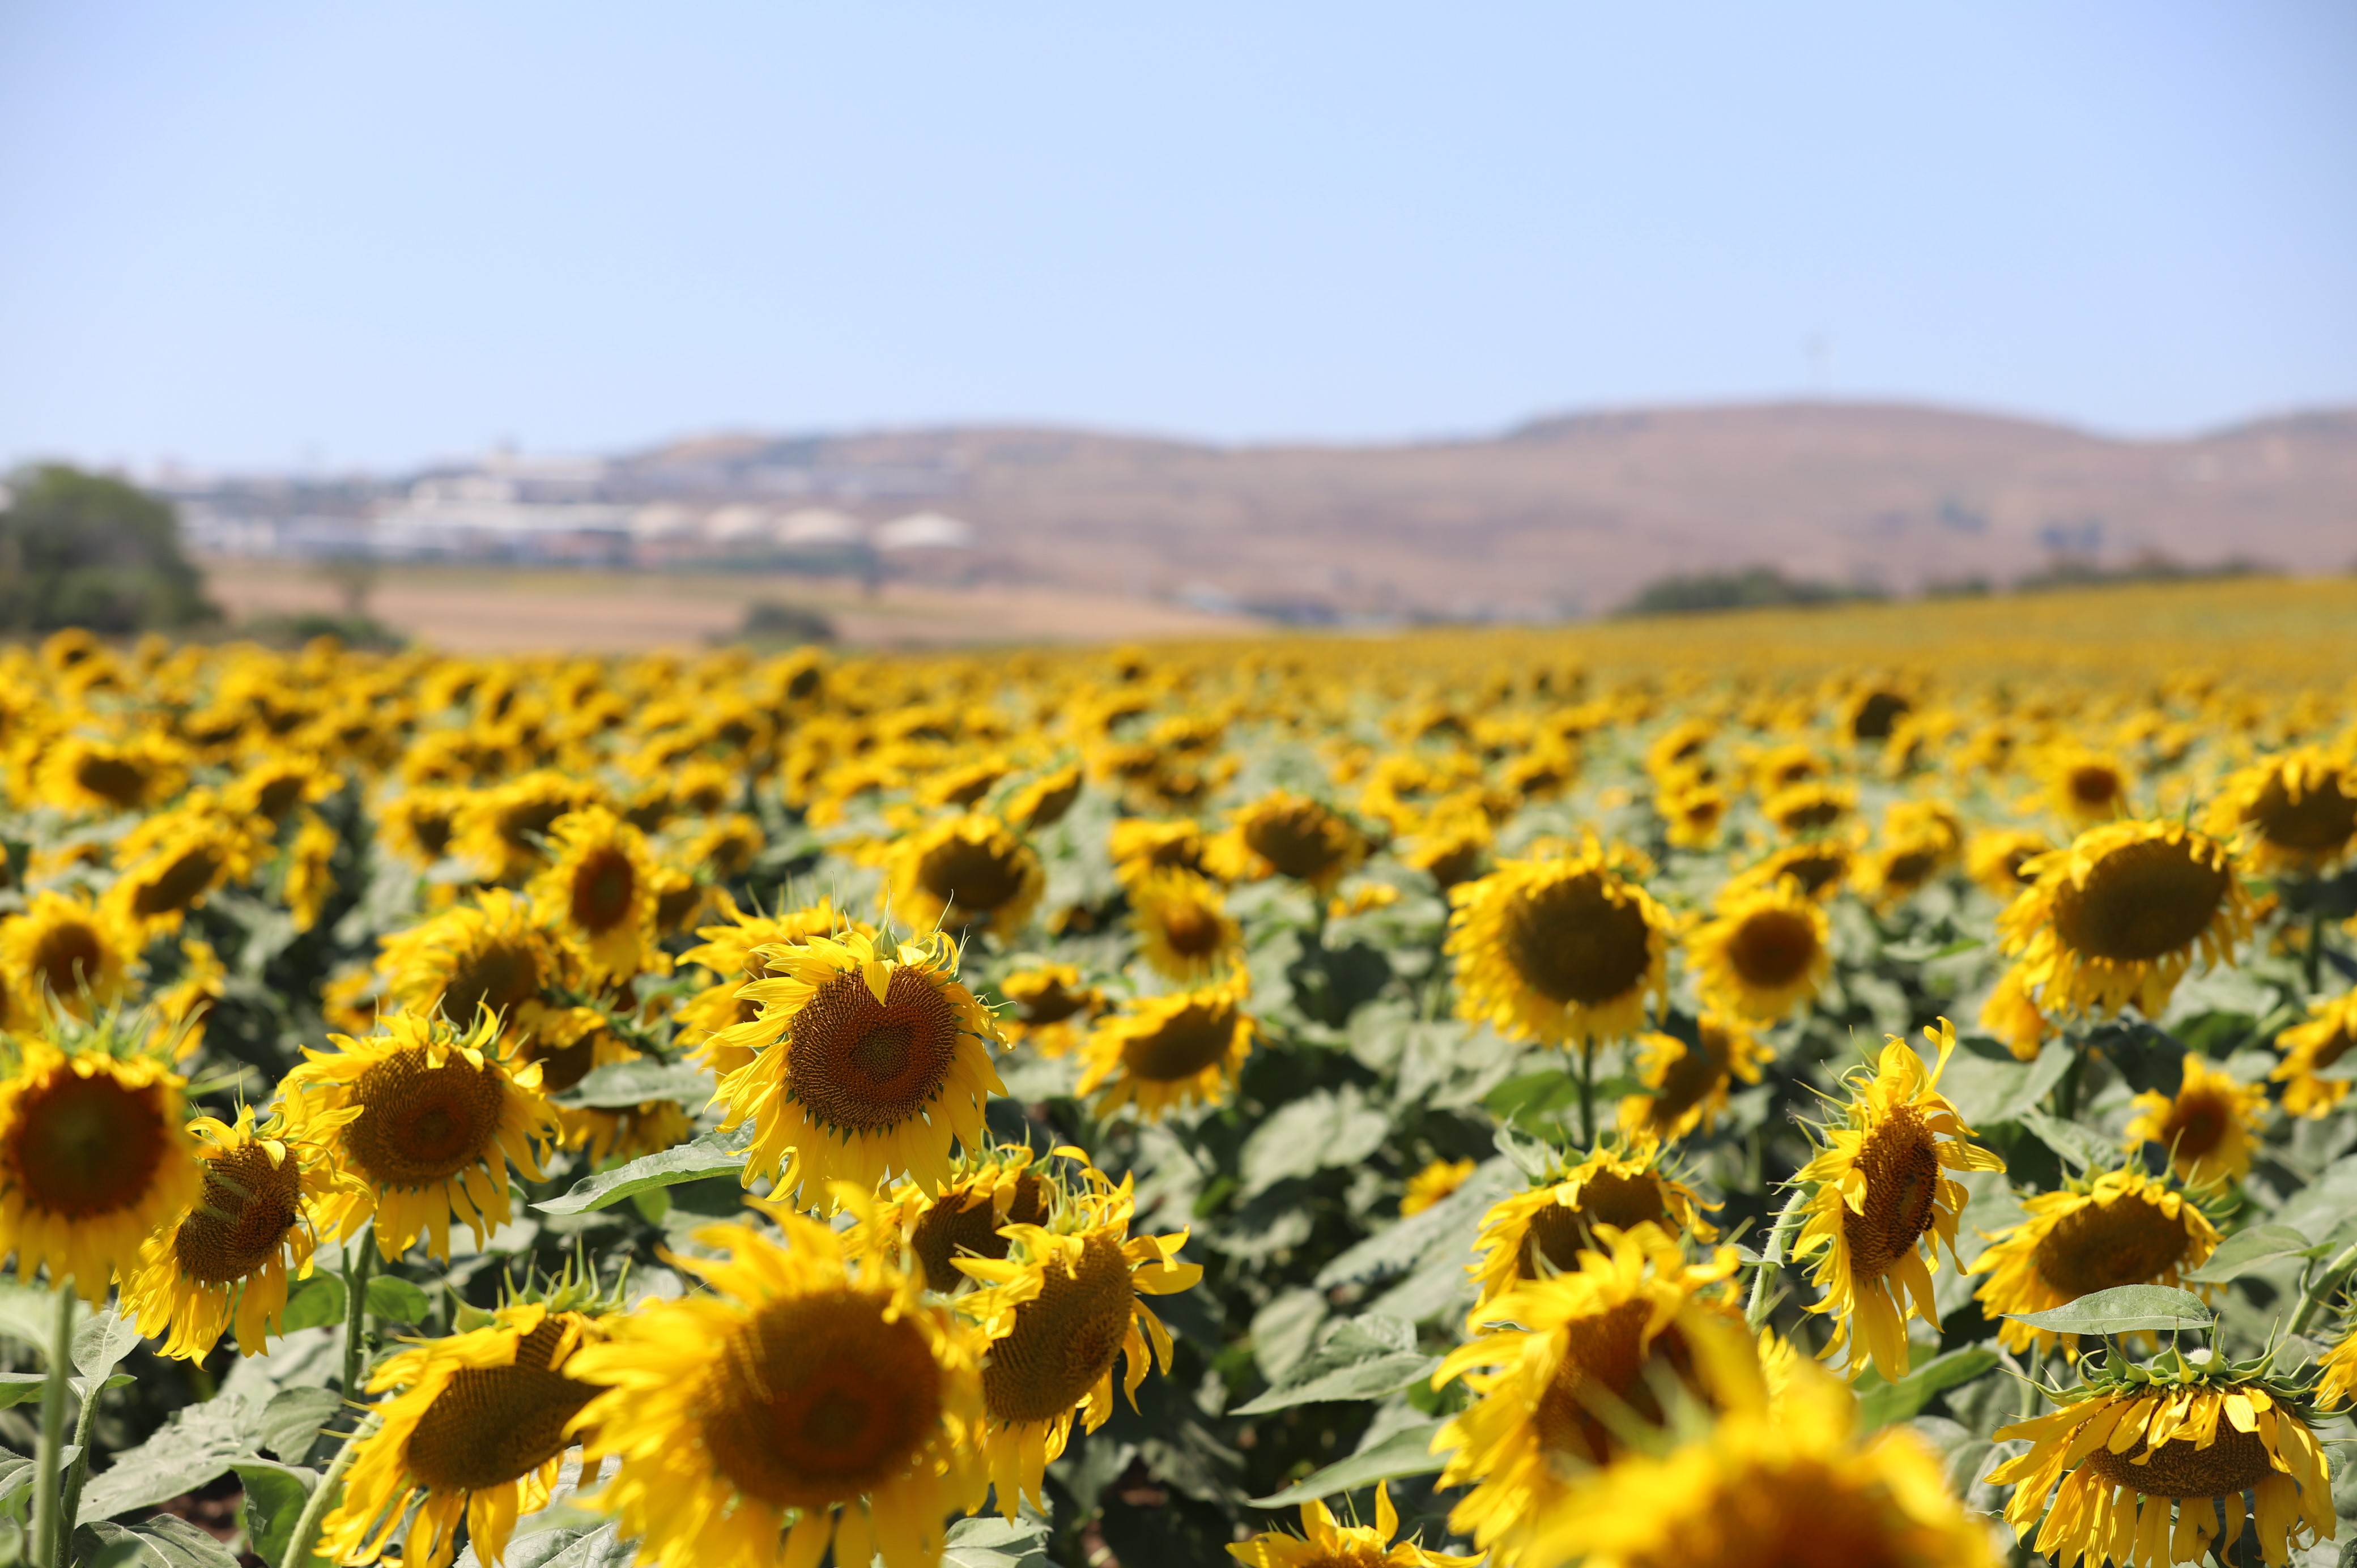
[0,462,219,632]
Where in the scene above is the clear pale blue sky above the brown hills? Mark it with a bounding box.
[0,0,2357,467]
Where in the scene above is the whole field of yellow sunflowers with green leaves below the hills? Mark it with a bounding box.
[0,582,2357,1568]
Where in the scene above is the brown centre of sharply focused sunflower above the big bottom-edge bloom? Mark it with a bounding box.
[785,969,957,1132]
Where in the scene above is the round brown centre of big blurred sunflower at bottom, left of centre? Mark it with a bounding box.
[703,1285,941,1509]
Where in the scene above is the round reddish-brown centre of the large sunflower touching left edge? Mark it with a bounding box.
[7,1071,167,1219]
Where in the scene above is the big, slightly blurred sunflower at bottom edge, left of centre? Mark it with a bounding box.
[565,1205,988,1568]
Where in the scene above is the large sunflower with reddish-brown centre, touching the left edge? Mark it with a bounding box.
[0,1021,198,1306]
